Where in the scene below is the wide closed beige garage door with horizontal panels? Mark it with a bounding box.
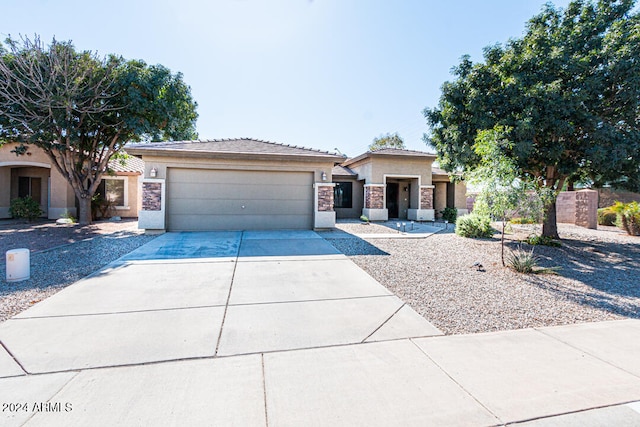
[167,168,313,231]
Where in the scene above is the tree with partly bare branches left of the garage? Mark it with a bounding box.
[0,37,197,224]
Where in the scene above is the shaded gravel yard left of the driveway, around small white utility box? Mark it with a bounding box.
[0,220,154,322]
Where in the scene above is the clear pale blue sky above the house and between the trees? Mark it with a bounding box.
[0,0,568,156]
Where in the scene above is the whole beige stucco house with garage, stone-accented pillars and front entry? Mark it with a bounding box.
[127,138,466,231]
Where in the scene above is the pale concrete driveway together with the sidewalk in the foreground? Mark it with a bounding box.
[0,231,640,426]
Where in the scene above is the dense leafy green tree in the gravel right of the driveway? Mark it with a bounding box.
[424,0,640,238]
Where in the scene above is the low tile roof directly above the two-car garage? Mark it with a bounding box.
[128,138,343,161]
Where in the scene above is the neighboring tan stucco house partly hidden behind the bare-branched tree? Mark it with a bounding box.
[0,143,144,219]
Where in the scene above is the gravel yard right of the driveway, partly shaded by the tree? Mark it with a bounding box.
[325,222,640,334]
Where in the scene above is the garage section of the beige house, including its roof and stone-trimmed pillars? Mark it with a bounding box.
[127,139,342,231]
